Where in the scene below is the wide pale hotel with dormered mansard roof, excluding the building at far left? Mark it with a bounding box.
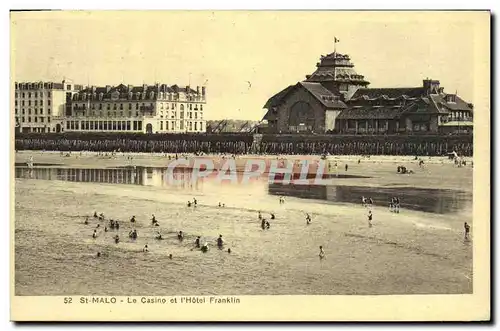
[64,84,206,133]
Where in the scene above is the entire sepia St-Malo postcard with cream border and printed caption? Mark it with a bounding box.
[10,10,491,321]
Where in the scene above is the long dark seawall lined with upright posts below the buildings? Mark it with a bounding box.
[15,135,473,156]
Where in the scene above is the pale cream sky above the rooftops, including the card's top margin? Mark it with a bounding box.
[11,11,489,120]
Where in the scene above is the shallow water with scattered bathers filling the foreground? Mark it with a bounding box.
[15,163,472,295]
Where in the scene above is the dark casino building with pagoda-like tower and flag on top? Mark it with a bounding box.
[263,47,473,134]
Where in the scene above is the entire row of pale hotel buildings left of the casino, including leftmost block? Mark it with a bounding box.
[14,81,206,133]
